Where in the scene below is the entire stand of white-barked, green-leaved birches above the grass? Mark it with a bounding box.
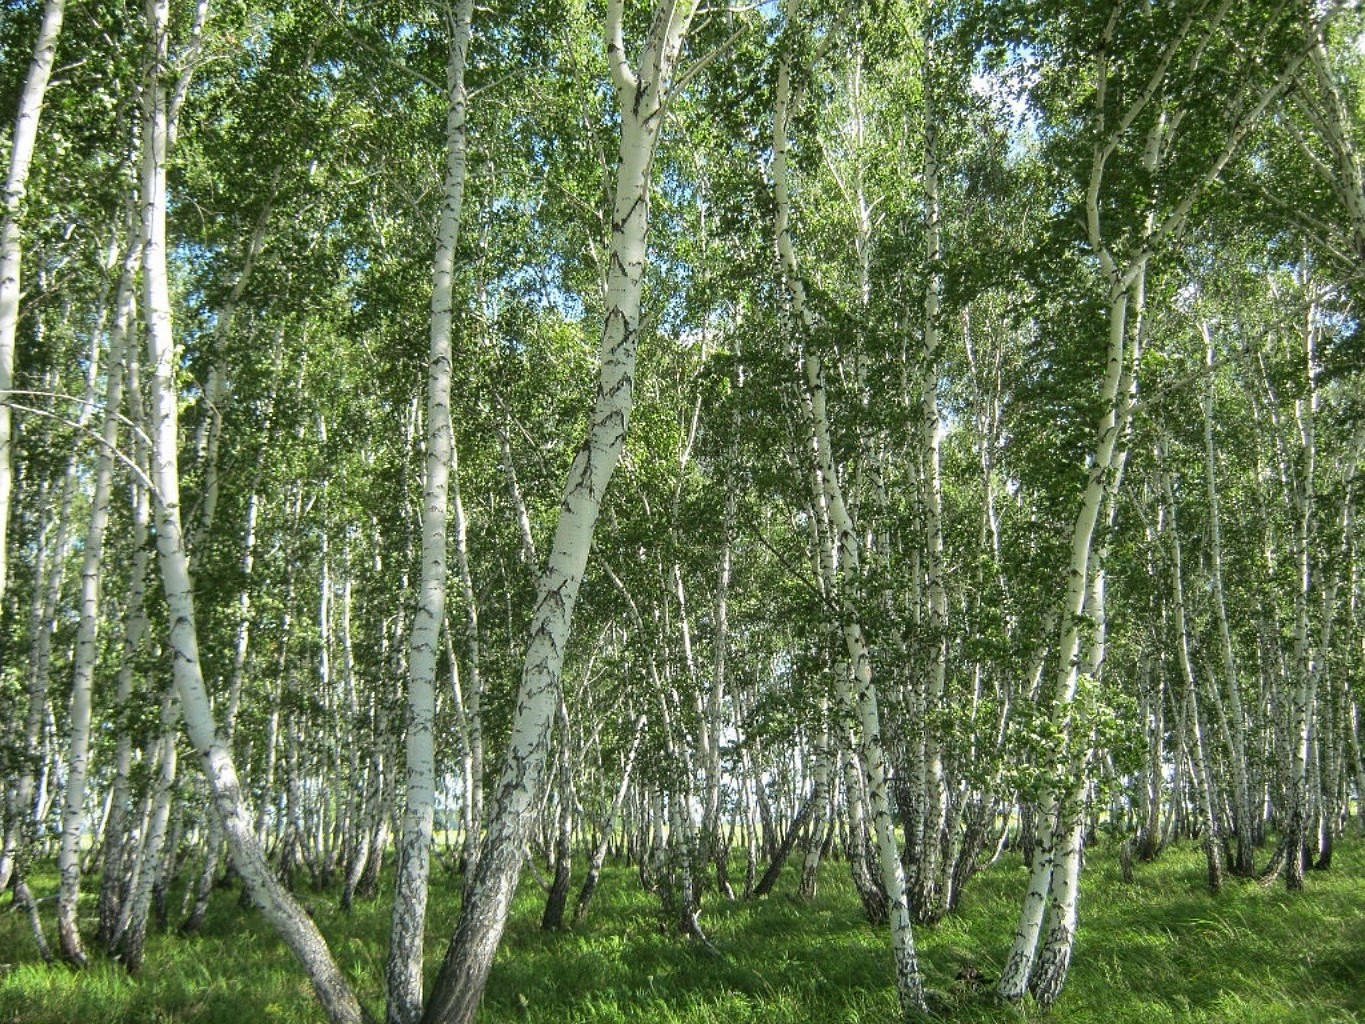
[0,0,1365,1024]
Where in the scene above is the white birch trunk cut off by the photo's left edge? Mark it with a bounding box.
[0,0,66,601]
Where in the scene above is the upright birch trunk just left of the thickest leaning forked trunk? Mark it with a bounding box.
[388,8,474,1024]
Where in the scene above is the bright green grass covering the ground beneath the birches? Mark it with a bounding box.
[0,841,1365,1024]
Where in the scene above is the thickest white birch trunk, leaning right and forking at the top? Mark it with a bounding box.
[423,8,696,1024]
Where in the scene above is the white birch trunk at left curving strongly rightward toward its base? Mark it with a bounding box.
[142,0,366,1024]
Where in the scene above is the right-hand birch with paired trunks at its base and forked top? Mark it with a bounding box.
[998,0,1308,1004]
